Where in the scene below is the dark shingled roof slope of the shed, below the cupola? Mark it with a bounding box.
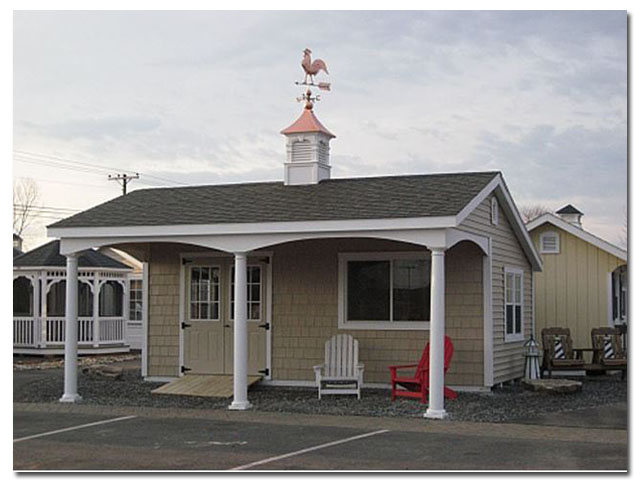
[50,171,499,228]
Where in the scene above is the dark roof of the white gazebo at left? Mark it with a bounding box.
[13,240,131,270]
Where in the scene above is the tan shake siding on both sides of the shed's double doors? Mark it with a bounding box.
[148,239,484,386]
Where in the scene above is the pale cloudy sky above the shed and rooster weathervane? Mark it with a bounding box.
[13,11,627,249]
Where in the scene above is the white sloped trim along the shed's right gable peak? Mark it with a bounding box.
[456,174,542,271]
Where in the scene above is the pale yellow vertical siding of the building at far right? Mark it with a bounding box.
[531,223,626,348]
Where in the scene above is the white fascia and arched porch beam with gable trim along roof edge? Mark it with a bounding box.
[47,174,542,271]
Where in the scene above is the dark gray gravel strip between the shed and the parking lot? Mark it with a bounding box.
[13,369,627,422]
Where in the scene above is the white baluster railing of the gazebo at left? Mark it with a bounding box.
[13,316,126,347]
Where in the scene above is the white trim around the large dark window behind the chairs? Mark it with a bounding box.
[338,251,431,331]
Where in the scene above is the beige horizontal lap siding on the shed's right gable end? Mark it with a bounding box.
[460,195,533,384]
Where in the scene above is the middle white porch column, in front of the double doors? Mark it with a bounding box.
[229,253,251,410]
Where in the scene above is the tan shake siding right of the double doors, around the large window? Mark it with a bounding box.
[272,240,483,385]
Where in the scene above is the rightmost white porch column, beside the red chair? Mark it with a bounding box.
[424,248,447,418]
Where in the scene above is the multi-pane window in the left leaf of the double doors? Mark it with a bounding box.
[189,266,220,321]
